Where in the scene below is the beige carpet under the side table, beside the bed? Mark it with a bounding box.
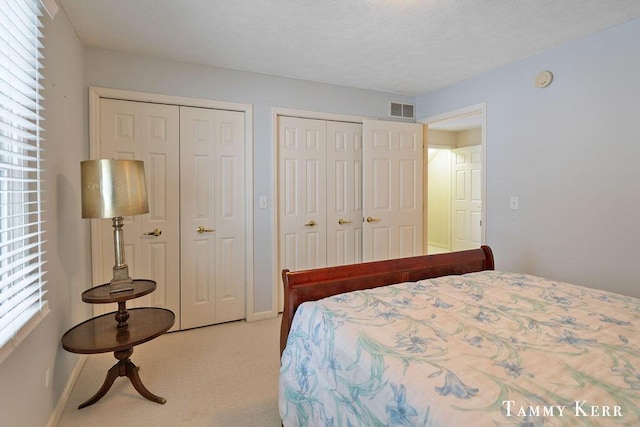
[58,317,280,427]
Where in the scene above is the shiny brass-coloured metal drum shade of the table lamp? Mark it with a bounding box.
[80,159,149,218]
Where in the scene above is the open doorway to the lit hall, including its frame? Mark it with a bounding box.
[422,104,486,254]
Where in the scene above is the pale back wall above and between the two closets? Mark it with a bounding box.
[85,48,413,313]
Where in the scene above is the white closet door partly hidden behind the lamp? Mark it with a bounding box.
[99,99,180,329]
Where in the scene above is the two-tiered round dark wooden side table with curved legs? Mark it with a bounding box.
[61,280,175,409]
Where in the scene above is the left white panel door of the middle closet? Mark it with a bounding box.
[278,117,327,271]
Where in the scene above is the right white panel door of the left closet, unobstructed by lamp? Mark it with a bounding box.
[180,107,246,329]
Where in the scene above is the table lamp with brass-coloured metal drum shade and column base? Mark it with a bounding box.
[80,159,149,293]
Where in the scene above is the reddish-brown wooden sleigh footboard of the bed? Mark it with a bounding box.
[280,246,495,354]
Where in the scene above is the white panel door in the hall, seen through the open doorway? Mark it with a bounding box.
[451,145,482,251]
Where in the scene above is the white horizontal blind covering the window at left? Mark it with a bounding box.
[0,0,46,347]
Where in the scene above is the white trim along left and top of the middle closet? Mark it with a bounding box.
[271,107,364,315]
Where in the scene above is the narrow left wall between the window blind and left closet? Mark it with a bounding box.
[0,5,90,427]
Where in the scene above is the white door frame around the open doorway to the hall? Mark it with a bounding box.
[418,102,487,251]
